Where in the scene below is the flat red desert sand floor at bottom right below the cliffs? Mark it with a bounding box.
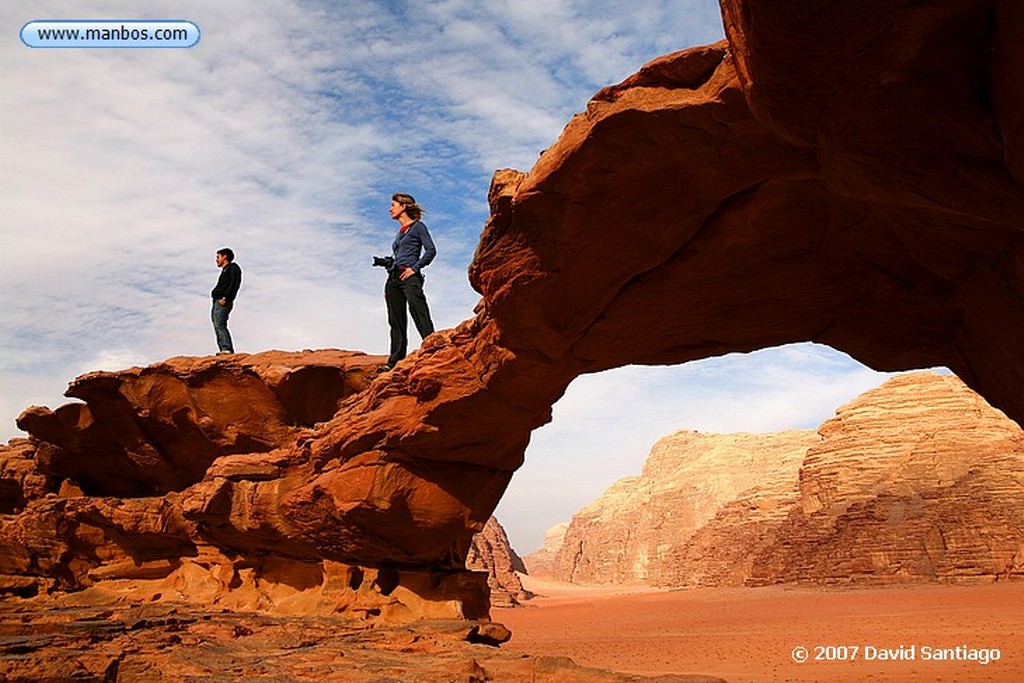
[492,577,1024,683]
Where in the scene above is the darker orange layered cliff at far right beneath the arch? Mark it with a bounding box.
[748,374,1024,584]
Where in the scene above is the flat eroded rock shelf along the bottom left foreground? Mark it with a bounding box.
[0,603,722,683]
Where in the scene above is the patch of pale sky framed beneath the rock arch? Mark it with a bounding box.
[496,344,901,553]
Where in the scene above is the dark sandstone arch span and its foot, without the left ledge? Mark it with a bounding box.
[283,0,1024,565]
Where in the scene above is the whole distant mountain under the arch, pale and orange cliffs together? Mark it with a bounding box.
[553,373,1024,586]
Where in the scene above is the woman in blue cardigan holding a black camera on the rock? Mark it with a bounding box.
[381,193,437,371]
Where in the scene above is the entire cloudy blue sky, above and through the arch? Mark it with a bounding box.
[0,0,909,553]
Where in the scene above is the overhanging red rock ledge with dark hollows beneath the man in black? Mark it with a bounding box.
[17,350,379,498]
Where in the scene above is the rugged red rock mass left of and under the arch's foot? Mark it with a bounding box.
[0,350,488,622]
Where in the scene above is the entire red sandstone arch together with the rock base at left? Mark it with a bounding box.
[8,0,1024,602]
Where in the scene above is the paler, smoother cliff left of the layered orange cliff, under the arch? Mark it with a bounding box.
[552,430,818,584]
